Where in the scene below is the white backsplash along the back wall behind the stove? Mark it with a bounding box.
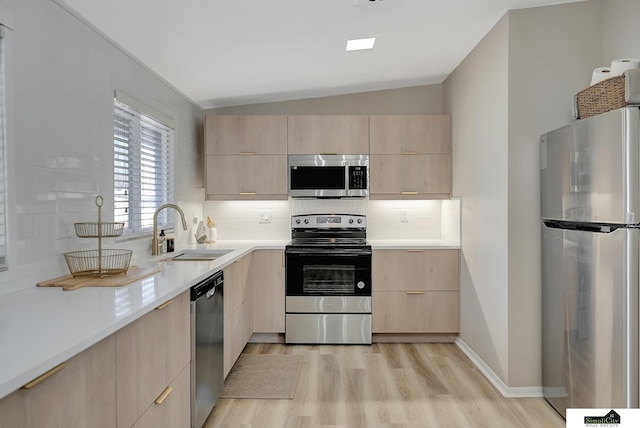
[204,199,460,245]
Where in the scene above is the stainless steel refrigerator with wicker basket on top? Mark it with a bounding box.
[540,107,640,417]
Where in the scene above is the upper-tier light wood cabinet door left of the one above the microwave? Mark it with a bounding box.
[204,115,287,155]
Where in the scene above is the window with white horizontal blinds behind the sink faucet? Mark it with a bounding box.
[113,93,174,237]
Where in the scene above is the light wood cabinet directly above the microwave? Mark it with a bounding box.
[287,115,369,155]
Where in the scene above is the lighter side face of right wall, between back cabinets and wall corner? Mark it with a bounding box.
[443,12,509,388]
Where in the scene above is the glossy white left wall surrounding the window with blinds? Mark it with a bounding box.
[0,0,203,293]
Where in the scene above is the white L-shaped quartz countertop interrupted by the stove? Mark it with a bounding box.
[0,240,460,398]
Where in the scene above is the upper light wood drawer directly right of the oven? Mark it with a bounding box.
[371,250,460,291]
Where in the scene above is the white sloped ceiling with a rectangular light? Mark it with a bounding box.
[59,0,580,108]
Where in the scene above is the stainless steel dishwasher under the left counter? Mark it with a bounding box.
[191,271,224,428]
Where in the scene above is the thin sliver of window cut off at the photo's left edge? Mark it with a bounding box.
[0,26,8,271]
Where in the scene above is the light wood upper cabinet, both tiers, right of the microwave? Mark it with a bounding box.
[369,115,451,199]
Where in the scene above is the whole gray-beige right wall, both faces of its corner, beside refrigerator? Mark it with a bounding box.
[443,0,640,396]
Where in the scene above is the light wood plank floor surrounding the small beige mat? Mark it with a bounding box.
[205,343,565,428]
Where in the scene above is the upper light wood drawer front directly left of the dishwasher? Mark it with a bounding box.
[116,291,191,427]
